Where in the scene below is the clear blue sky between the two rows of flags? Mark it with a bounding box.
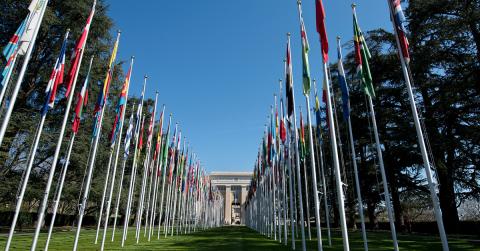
[107,0,392,171]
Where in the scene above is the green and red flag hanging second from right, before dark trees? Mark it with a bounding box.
[353,10,375,97]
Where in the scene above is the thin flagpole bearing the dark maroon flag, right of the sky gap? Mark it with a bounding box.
[287,33,307,251]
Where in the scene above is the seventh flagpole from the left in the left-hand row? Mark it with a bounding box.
[118,75,148,247]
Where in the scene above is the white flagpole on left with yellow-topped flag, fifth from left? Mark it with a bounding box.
[73,31,120,251]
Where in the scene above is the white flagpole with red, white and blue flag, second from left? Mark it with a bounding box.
[5,24,66,250]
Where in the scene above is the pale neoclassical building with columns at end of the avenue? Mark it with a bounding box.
[210,172,252,225]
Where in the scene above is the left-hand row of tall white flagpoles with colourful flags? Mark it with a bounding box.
[0,0,224,250]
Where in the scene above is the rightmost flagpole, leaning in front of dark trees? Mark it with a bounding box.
[387,0,449,251]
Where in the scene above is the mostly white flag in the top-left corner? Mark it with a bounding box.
[18,0,48,55]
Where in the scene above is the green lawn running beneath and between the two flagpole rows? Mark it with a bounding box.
[0,227,480,251]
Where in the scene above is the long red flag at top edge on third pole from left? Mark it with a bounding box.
[65,1,96,97]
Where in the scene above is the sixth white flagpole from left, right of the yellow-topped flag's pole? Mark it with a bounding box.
[99,57,135,251]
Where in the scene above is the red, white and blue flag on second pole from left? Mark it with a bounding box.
[42,31,69,114]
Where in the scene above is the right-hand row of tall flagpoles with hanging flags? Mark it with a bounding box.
[245,0,449,251]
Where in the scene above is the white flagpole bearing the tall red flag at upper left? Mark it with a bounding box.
[31,23,95,247]
